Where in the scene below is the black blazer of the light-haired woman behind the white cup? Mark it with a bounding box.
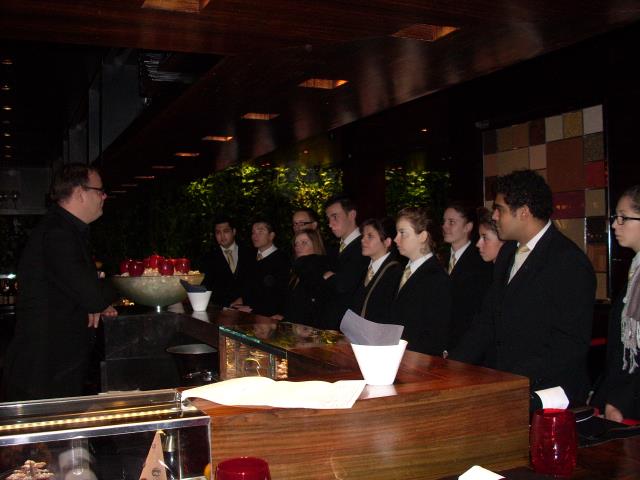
[392,256,451,356]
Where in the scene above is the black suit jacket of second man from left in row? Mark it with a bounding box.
[242,249,291,316]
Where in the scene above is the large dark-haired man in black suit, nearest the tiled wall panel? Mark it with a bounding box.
[450,170,596,404]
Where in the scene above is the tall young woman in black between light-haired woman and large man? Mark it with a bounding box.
[442,203,493,348]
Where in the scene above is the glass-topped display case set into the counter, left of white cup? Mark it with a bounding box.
[220,321,346,380]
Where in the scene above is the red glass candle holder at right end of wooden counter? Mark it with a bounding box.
[530,408,578,477]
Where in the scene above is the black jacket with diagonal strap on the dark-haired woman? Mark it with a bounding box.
[351,253,406,323]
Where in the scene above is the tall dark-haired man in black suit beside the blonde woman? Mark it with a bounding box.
[323,195,369,330]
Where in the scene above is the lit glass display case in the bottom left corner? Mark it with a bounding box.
[0,390,211,480]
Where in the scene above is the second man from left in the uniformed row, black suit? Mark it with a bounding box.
[233,220,291,316]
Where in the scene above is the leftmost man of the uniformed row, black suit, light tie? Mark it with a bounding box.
[202,217,255,307]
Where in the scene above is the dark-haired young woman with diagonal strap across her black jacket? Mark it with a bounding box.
[351,217,405,323]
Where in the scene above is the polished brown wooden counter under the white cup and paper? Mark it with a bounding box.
[189,312,529,479]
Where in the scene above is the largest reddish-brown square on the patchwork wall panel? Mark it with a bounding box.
[547,137,584,192]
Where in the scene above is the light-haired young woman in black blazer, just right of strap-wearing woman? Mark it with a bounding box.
[392,207,451,355]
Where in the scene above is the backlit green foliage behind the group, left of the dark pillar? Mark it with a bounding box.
[92,164,342,271]
